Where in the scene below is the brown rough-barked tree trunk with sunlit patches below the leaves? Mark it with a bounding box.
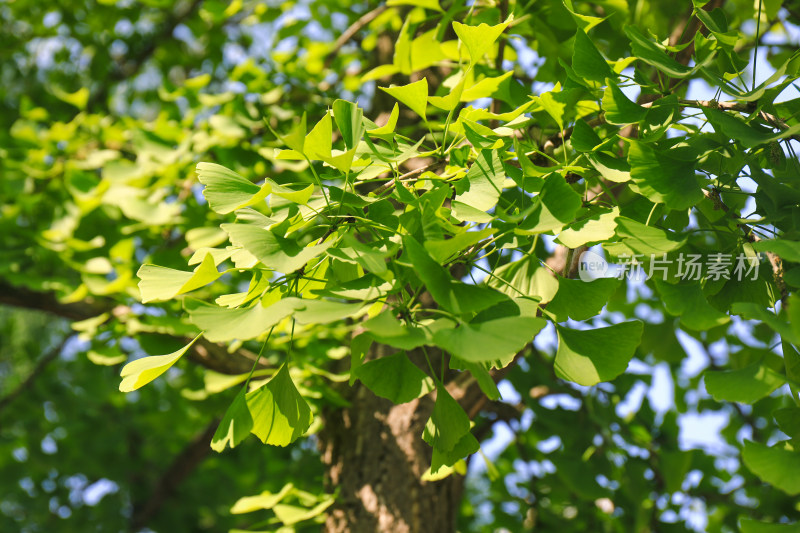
[320,385,464,533]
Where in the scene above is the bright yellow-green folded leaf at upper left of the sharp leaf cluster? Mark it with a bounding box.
[197,163,271,215]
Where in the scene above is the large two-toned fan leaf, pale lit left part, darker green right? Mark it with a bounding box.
[555,320,642,386]
